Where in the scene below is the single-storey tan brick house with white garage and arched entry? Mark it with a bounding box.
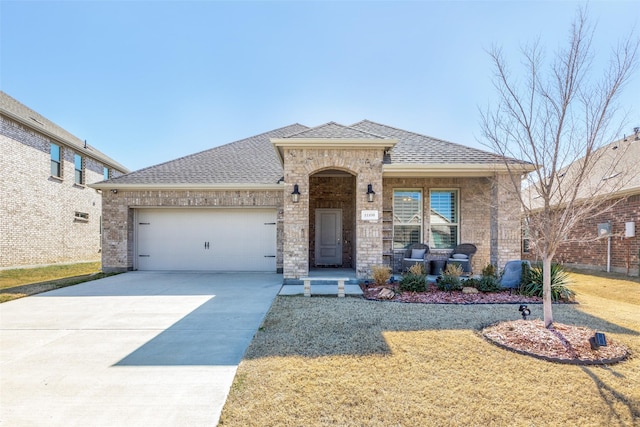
[93,120,531,280]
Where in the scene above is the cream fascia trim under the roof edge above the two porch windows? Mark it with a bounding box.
[382,163,535,178]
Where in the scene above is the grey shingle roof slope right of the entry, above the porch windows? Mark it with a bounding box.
[351,120,533,176]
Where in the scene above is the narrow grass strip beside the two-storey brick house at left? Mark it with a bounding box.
[0,262,105,303]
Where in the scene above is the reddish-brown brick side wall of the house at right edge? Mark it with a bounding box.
[523,194,640,276]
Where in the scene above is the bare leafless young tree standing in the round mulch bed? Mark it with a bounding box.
[481,5,639,328]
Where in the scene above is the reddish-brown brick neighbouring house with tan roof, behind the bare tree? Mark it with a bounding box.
[523,128,640,276]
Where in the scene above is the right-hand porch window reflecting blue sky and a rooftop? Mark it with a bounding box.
[429,190,460,249]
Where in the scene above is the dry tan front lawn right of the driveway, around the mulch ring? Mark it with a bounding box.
[220,273,640,427]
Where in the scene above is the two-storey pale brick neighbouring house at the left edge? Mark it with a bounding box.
[0,92,128,268]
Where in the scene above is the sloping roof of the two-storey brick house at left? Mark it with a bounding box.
[0,91,129,173]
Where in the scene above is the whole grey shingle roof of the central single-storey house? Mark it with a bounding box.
[108,120,525,186]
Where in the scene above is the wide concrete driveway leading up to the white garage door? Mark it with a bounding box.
[0,272,282,427]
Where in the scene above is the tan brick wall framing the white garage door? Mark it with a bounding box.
[102,190,284,272]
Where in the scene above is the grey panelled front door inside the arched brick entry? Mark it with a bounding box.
[315,209,342,266]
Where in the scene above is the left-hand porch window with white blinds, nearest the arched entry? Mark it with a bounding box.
[393,190,422,249]
